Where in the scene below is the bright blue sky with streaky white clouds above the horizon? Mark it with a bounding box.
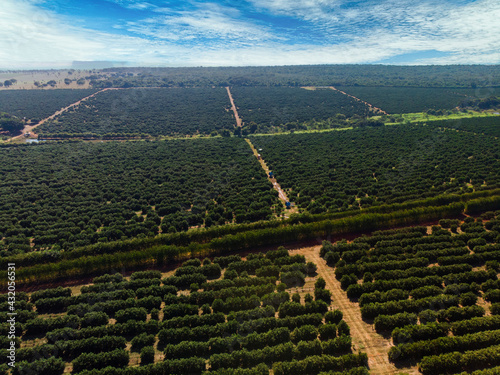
[0,0,500,69]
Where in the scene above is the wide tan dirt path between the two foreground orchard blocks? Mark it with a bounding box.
[290,246,419,375]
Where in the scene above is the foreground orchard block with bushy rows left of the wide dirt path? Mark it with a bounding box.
[1,248,368,375]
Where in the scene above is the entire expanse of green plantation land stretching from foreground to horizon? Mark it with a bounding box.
[0,65,500,375]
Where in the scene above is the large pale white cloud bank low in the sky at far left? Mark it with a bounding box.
[0,0,191,68]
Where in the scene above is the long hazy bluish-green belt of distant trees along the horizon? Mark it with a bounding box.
[86,65,500,89]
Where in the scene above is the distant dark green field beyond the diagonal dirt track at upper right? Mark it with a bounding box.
[336,86,476,113]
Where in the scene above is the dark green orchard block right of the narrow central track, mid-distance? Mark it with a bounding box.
[252,125,500,213]
